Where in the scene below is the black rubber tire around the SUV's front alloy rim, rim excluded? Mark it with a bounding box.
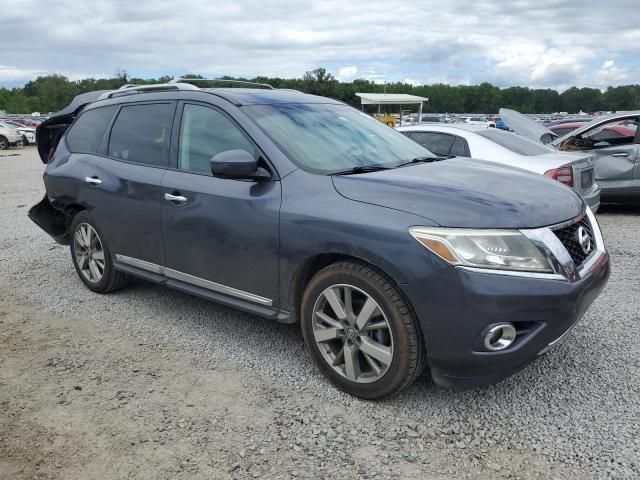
[300,265,418,399]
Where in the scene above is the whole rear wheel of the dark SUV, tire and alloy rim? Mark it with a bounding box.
[69,212,129,293]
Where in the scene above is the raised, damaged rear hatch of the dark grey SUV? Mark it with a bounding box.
[36,90,109,163]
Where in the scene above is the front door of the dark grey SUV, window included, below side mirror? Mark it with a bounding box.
[162,102,281,306]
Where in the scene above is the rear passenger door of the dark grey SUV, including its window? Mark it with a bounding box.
[84,101,176,266]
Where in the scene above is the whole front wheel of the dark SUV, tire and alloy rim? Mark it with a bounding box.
[301,262,426,399]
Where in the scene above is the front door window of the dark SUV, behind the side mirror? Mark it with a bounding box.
[178,104,255,174]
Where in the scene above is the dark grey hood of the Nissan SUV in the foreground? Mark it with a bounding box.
[333,158,584,228]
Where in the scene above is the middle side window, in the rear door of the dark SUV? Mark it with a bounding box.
[108,103,174,167]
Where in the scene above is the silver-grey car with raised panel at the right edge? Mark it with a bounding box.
[500,109,640,203]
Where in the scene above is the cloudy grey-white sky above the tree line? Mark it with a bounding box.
[0,0,640,91]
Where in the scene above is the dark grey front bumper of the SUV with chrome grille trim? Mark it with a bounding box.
[401,210,610,387]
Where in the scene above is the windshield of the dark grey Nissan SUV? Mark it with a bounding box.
[243,104,434,174]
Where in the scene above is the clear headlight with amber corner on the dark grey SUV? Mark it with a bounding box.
[409,227,554,273]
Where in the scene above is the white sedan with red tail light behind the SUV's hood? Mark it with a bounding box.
[397,123,600,212]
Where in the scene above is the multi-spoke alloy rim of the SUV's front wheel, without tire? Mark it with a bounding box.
[313,284,393,383]
